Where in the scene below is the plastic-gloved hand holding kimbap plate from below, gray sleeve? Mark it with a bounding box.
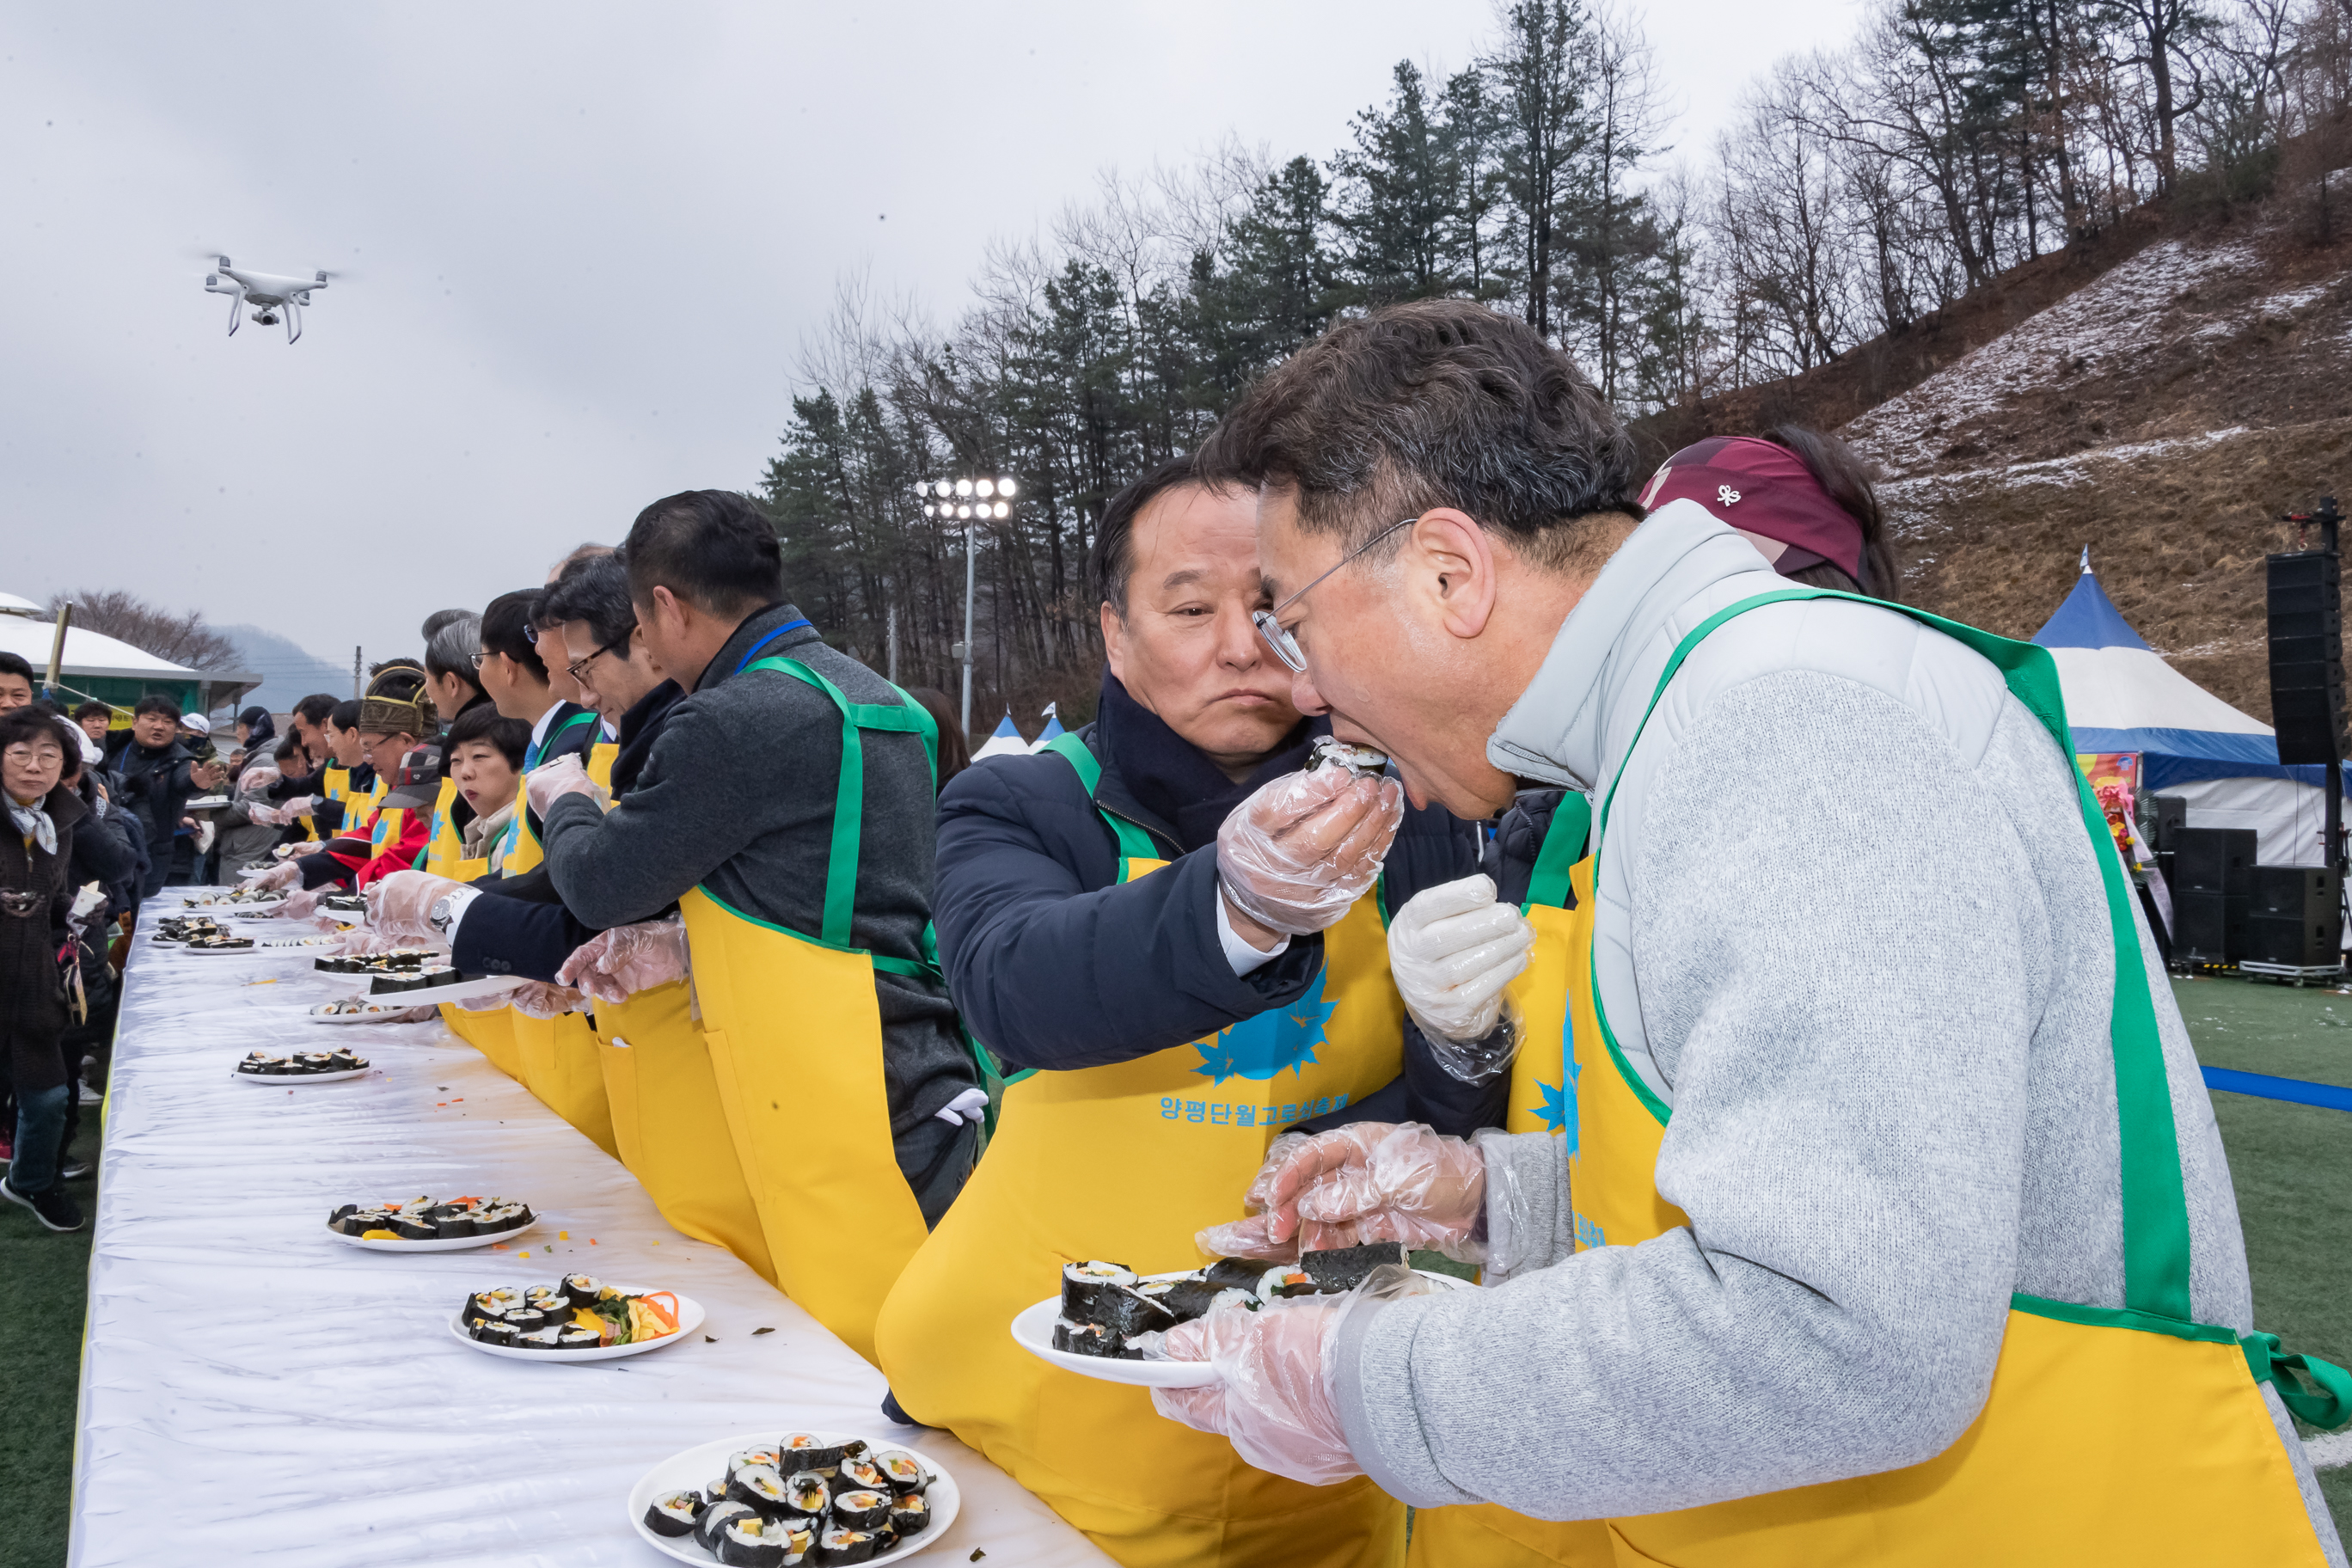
[1153,1265,1435,1485]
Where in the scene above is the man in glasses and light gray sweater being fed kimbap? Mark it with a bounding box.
[1155,301,2352,1568]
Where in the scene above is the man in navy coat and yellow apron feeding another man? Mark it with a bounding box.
[878,444,1528,1568]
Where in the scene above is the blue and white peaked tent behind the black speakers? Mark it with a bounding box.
[2035,550,2326,865]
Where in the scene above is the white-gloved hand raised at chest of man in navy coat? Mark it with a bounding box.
[1387,877,1536,1084]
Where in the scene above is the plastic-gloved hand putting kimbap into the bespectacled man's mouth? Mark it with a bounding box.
[1216,769,1404,935]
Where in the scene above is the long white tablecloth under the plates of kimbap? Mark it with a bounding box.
[68,889,1110,1568]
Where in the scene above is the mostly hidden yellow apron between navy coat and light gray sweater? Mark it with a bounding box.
[1406,793,1627,1568]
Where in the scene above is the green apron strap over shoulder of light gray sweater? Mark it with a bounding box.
[1592,588,2192,1324]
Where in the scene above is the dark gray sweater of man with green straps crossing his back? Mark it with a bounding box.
[546,604,978,1178]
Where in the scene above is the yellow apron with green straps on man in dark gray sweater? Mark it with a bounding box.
[680,658,939,1361]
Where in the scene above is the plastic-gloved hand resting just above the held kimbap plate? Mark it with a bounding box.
[1199,1121,1486,1262]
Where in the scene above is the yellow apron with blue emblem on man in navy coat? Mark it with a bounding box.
[875,736,1404,1568]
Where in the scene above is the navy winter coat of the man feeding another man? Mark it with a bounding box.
[934,675,1510,1136]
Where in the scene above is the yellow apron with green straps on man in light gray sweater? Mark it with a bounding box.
[1542,588,2352,1568]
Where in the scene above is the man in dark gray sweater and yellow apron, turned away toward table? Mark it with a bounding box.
[530,492,985,1351]
